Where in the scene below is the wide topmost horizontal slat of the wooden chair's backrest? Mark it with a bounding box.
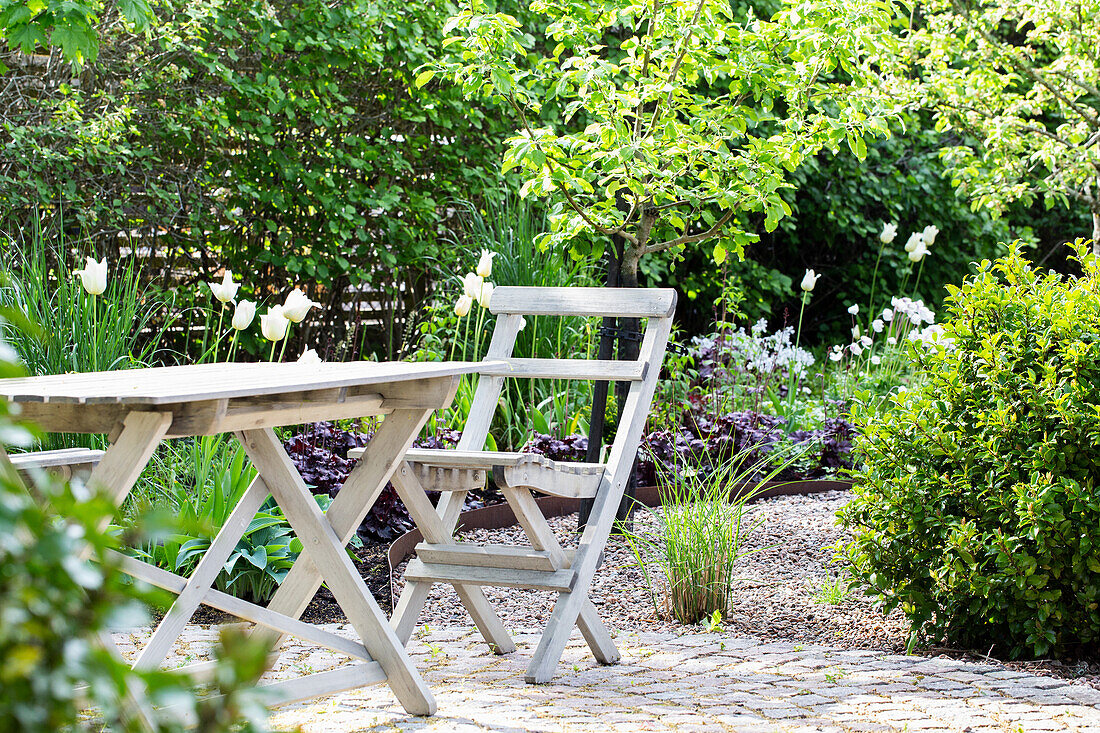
[488,286,677,318]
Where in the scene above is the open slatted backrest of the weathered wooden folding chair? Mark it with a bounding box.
[458,286,677,464]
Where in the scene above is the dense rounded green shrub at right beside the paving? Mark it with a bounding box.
[840,241,1100,657]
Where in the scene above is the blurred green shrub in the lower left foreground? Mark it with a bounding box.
[0,365,268,733]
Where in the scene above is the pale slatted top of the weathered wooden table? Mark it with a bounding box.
[0,361,505,405]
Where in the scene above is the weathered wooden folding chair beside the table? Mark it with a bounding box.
[380,287,677,682]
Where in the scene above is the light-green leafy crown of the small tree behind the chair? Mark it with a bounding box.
[418,0,894,286]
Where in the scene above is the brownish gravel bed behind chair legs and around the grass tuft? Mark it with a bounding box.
[394,491,906,650]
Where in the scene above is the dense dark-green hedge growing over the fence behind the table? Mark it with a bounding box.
[0,0,519,349]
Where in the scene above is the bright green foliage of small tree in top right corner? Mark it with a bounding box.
[901,0,1100,252]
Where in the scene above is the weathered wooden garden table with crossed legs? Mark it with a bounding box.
[0,362,483,715]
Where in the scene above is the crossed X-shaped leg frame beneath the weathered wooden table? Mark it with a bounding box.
[89,408,436,715]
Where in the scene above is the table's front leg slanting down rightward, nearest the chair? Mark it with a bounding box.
[240,419,436,715]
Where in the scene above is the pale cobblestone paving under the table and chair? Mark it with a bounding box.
[118,625,1100,733]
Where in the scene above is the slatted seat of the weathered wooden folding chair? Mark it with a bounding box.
[405,448,605,499]
